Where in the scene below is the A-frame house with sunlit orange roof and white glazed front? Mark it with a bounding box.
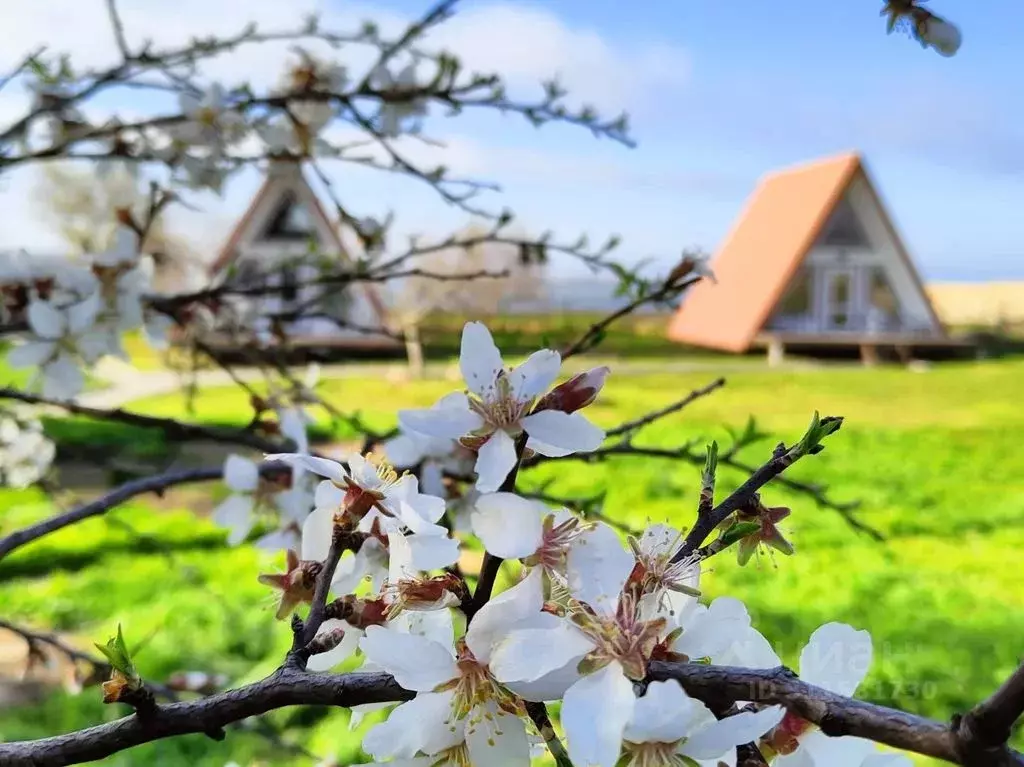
[668,153,962,360]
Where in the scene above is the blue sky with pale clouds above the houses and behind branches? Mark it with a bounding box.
[0,0,1024,280]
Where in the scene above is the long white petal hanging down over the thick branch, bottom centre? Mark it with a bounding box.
[561,662,636,767]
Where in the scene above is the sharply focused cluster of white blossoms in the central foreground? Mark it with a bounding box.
[243,323,909,767]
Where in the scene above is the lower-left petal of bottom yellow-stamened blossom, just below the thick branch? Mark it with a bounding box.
[362,692,463,764]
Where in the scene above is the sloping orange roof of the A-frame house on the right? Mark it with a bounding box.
[669,153,937,352]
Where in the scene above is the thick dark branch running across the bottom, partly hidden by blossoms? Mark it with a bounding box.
[0,662,1024,767]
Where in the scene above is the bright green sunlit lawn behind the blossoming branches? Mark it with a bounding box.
[0,361,1024,767]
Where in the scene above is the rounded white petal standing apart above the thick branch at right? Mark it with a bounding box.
[800,623,871,695]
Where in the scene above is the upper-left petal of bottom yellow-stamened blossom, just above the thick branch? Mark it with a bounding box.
[359,626,459,692]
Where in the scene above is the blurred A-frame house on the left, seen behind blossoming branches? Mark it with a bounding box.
[210,159,398,350]
